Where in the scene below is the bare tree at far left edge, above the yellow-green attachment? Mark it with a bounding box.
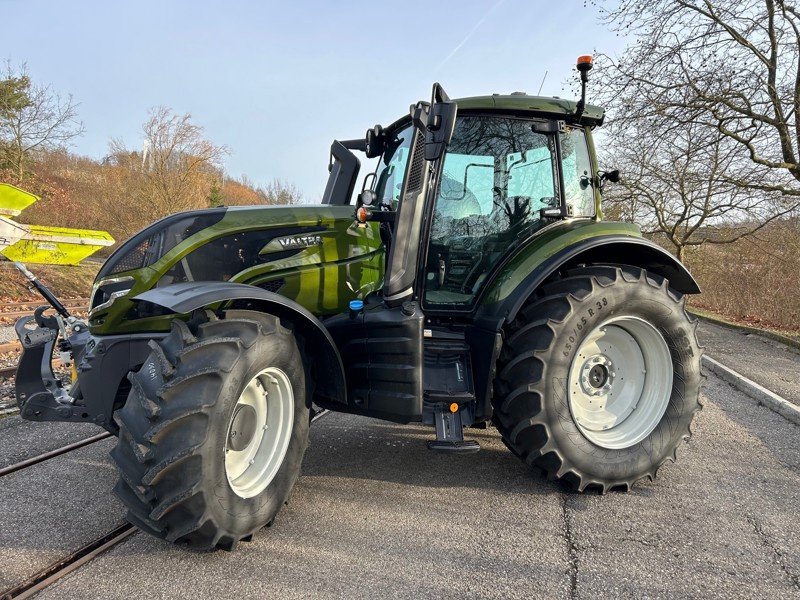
[0,62,83,180]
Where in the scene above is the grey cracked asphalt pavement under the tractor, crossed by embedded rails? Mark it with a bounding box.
[0,370,800,600]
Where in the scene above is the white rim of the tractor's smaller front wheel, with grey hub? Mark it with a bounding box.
[225,367,294,498]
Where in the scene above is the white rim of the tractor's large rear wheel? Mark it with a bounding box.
[568,317,673,449]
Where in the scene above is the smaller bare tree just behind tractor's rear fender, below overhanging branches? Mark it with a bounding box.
[605,121,794,260]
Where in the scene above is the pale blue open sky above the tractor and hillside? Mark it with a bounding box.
[0,0,624,202]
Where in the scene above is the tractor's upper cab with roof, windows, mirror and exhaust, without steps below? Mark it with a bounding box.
[323,84,603,313]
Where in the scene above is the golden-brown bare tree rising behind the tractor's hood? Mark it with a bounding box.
[111,106,227,221]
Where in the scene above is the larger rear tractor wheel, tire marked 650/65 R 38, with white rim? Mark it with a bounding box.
[493,266,702,493]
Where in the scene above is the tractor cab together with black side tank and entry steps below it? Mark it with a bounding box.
[324,75,603,451]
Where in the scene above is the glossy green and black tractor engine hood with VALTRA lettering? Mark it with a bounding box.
[90,205,384,338]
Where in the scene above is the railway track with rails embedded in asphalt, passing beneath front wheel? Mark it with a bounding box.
[0,410,330,600]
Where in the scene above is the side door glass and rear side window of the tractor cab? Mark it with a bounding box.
[424,115,594,308]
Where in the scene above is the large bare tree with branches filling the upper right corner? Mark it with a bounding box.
[596,0,800,198]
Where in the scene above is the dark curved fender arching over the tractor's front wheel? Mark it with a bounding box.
[133,281,347,405]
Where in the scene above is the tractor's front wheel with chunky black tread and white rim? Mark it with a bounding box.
[111,310,309,550]
